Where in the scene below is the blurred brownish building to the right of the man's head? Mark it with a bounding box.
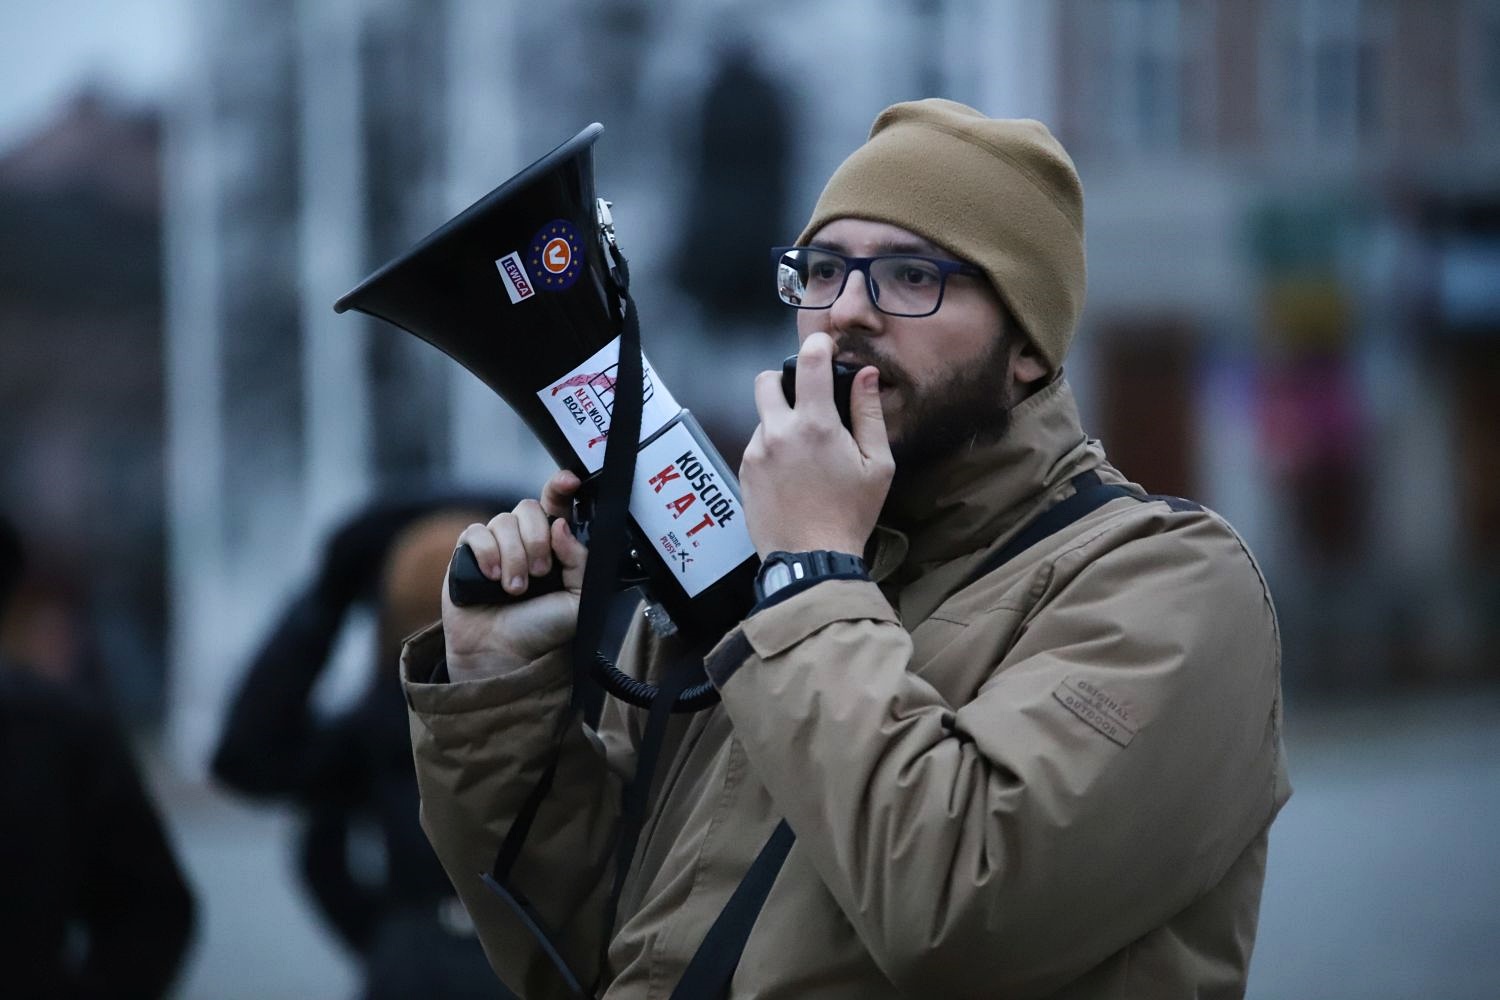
[1056,0,1500,687]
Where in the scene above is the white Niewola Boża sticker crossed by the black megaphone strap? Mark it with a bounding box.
[537,337,683,472]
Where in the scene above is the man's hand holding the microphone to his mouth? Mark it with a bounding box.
[740,333,896,558]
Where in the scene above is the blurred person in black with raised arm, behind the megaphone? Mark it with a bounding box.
[213,498,513,1000]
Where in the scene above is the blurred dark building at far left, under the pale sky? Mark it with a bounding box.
[0,88,165,720]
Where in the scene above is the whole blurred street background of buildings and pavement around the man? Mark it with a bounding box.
[0,0,1500,1000]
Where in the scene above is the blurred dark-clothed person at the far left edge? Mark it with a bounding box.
[0,516,194,1000]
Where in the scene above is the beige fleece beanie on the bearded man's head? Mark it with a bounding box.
[797,97,1085,370]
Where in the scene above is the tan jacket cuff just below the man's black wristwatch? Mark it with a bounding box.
[704,579,900,688]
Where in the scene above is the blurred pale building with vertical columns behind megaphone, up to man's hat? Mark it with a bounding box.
[167,0,1041,769]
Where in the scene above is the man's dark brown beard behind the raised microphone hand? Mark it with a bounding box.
[839,330,1013,483]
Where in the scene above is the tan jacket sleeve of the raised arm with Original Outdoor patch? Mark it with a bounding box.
[710,514,1280,997]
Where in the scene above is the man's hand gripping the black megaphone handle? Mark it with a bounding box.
[443,471,588,681]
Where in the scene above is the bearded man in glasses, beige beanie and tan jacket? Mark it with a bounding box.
[404,100,1290,999]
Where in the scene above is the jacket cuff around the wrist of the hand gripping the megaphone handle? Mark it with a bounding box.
[401,624,573,715]
